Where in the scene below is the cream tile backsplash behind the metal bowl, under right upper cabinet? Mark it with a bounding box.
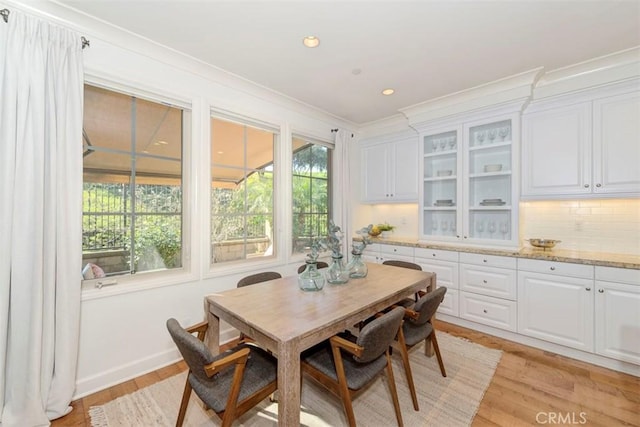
[520,199,640,255]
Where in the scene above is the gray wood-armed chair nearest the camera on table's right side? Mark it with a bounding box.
[301,307,405,427]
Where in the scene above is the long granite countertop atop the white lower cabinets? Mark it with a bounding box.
[362,237,640,270]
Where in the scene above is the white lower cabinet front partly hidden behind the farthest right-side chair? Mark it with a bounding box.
[414,248,460,317]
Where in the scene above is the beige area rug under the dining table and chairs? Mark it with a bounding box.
[89,333,502,427]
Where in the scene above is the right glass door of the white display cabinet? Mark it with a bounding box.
[464,120,514,241]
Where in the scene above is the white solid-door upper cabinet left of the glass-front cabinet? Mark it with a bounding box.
[361,133,418,203]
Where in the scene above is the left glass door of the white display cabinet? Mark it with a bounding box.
[422,130,460,238]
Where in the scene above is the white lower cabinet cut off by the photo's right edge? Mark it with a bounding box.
[595,267,640,365]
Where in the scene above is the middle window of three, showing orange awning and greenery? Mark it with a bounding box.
[211,117,279,265]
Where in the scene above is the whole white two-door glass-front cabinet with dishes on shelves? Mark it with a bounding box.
[420,114,520,247]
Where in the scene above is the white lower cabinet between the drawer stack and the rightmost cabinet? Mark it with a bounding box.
[518,259,594,352]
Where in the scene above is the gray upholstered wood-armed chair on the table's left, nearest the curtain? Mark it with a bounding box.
[167,318,277,427]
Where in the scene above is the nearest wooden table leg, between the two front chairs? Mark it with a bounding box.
[278,343,301,427]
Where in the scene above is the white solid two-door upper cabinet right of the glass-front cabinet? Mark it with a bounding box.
[522,86,640,198]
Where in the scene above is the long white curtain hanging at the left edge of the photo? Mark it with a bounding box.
[0,10,83,427]
